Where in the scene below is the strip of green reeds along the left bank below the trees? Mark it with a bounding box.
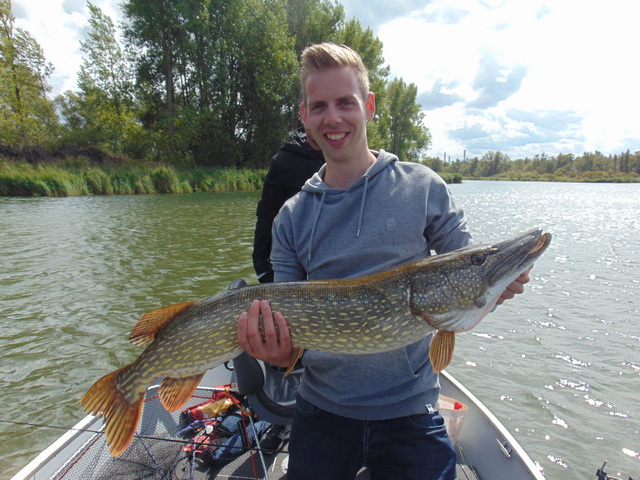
[0,159,266,197]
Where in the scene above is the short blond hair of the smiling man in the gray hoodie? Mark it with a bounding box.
[300,42,369,103]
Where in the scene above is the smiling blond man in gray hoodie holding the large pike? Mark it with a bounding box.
[238,43,528,480]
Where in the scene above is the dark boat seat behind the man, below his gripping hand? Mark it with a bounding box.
[229,280,304,425]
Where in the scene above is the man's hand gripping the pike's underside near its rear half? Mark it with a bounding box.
[238,300,296,367]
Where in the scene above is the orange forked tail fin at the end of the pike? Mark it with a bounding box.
[80,367,144,457]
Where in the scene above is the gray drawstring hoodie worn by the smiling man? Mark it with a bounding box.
[271,151,473,420]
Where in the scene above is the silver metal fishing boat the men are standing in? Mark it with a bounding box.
[13,360,544,480]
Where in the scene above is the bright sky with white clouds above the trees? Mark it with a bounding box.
[13,0,640,161]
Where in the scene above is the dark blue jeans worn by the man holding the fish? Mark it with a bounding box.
[287,395,456,480]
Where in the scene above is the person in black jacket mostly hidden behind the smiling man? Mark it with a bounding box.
[253,127,324,283]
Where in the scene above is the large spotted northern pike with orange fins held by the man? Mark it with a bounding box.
[81,229,551,456]
